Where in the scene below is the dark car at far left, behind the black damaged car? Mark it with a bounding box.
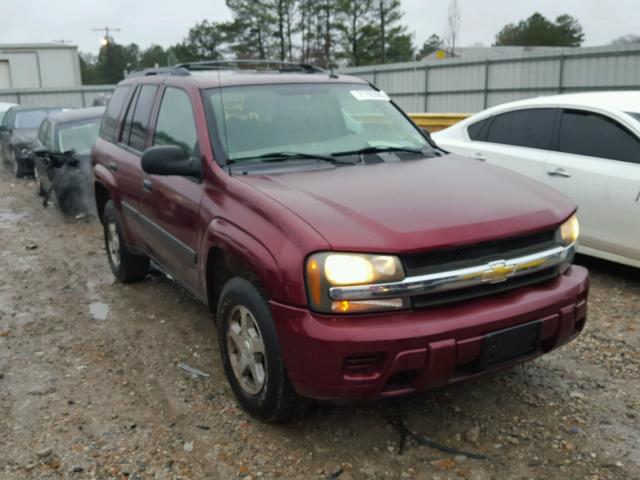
[0,106,65,178]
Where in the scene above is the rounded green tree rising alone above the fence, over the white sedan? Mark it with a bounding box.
[495,12,584,47]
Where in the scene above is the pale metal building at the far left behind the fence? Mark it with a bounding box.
[0,43,82,90]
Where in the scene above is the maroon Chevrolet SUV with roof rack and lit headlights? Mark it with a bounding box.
[93,62,589,421]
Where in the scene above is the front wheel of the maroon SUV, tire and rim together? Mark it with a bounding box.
[217,277,302,423]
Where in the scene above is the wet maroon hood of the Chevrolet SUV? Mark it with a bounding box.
[237,155,575,253]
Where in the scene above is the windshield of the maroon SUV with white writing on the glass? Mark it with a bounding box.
[205,83,429,161]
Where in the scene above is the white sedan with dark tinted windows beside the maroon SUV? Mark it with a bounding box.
[433,91,640,268]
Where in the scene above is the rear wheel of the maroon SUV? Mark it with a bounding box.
[103,200,149,283]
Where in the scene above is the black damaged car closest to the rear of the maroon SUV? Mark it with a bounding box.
[33,107,105,215]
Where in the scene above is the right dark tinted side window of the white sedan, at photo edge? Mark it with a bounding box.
[558,110,640,163]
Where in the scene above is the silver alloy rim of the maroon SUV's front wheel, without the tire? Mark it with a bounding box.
[227,305,267,395]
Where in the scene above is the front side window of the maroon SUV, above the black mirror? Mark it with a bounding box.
[153,88,198,156]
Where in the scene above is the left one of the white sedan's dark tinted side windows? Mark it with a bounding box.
[487,108,556,149]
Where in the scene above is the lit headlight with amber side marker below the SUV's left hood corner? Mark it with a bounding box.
[305,252,407,313]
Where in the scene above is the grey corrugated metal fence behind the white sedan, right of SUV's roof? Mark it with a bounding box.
[343,45,640,113]
